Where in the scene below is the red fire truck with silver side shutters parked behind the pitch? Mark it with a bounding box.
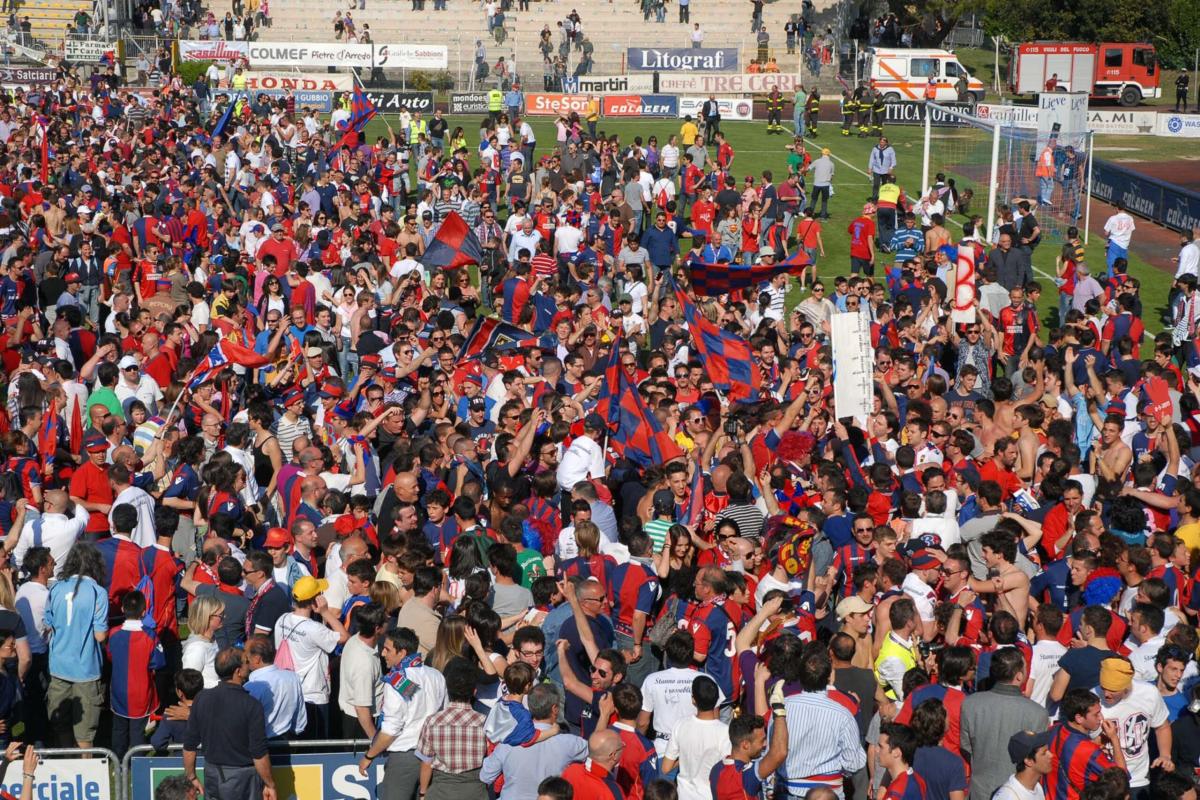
[1008,42,1162,107]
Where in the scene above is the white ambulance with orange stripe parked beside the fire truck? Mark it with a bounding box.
[865,48,986,103]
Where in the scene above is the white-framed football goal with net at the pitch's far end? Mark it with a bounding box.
[925,104,1091,243]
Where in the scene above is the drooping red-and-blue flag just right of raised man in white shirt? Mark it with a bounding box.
[595,333,684,468]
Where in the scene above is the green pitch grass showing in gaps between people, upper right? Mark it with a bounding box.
[355,116,1171,332]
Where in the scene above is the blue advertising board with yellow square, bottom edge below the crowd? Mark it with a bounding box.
[129,753,384,800]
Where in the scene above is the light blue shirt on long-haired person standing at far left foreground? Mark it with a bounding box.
[46,577,108,684]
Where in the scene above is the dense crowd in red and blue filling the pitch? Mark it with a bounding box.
[0,51,1200,800]
